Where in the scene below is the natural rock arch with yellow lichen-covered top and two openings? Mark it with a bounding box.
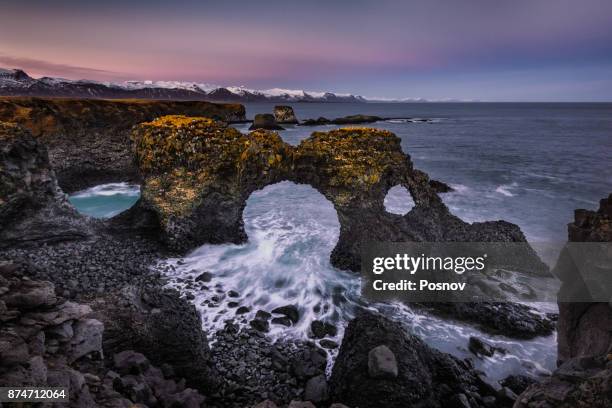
[132,116,537,271]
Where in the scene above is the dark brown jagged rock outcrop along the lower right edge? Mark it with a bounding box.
[515,195,612,408]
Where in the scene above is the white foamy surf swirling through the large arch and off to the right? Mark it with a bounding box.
[157,182,555,380]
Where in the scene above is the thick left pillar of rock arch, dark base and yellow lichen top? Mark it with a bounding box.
[132,116,293,250]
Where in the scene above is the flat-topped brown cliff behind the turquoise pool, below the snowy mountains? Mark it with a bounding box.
[0,97,245,193]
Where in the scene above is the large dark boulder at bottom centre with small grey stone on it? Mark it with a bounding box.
[330,312,502,408]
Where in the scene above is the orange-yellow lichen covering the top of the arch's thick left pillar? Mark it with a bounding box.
[132,115,293,222]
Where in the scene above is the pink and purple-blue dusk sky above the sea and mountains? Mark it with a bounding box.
[0,0,612,101]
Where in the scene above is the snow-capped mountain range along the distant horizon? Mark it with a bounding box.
[0,68,366,102]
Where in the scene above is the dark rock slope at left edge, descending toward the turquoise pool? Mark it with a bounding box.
[0,122,93,248]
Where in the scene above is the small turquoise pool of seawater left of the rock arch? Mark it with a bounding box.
[68,182,140,219]
